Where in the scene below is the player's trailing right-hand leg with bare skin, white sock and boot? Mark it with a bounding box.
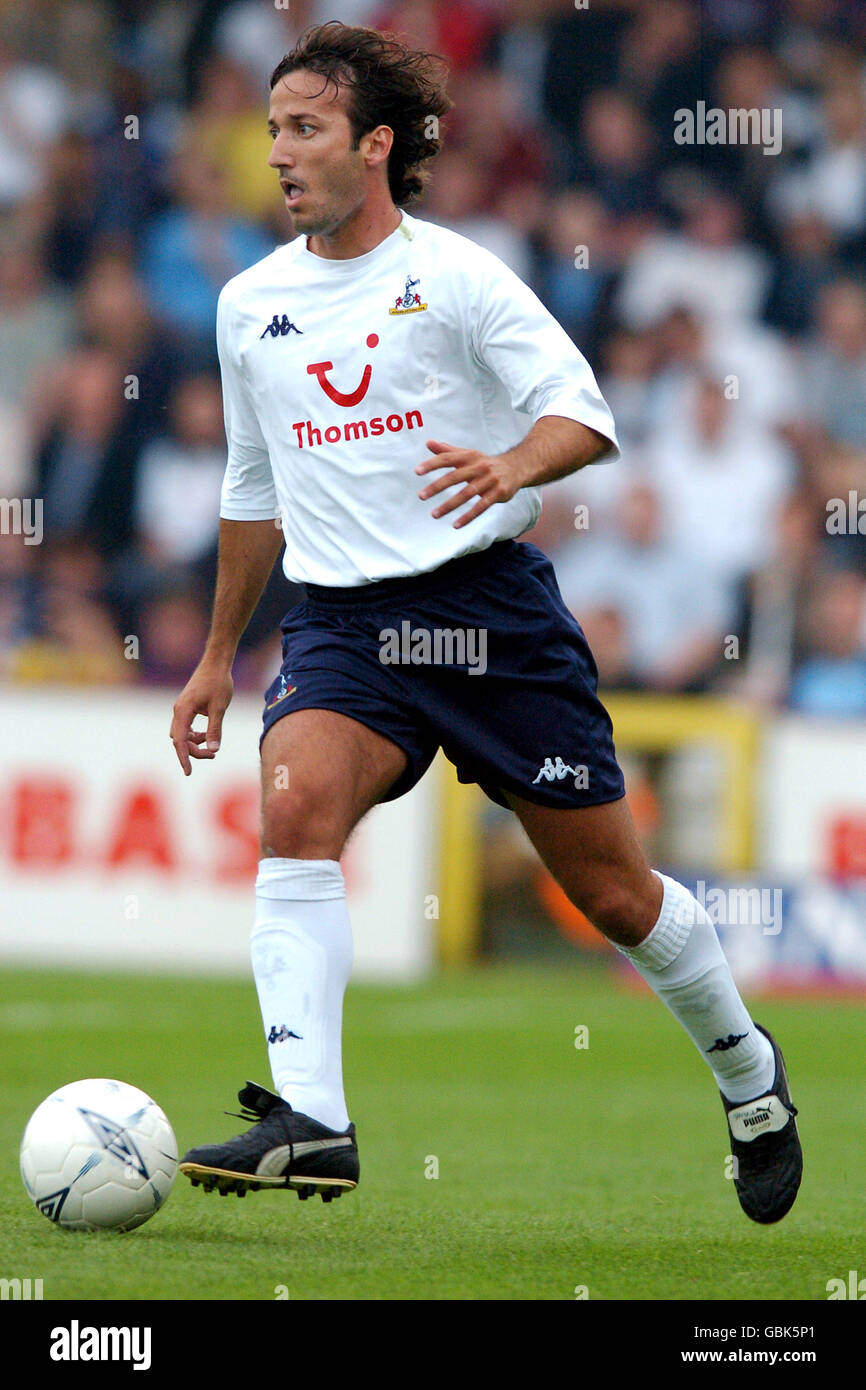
[507,794,802,1222]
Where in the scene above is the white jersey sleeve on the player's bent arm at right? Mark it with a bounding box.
[471,253,620,463]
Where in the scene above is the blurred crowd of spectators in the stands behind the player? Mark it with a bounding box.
[0,0,866,716]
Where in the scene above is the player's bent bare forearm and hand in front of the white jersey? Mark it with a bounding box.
[416,416,612,528]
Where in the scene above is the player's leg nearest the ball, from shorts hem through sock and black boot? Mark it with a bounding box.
[181,709,407,1201]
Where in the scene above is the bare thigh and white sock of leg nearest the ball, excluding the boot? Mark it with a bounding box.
[252,709,407,1130]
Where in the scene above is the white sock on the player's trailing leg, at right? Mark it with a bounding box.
[617,873,776,1101]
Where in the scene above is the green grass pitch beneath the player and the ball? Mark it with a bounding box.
[0,967,866,1300]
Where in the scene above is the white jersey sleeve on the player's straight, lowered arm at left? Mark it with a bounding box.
[217,288,279,521]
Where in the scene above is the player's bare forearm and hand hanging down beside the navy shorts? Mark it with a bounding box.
[171,518,282,777]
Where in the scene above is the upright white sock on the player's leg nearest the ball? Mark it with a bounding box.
[250,859,352,1130]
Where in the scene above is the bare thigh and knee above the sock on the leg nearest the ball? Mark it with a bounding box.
[261,709,407,859]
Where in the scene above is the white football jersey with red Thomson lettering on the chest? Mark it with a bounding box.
[217,213,619,587]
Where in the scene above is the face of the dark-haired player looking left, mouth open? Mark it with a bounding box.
[268,70,370,236]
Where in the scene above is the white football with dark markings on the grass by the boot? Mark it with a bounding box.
[21,1079,178,1230]
